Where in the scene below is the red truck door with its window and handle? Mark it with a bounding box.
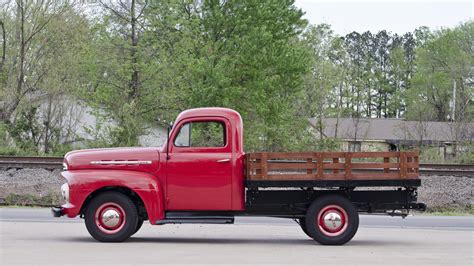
[166,117,233,210]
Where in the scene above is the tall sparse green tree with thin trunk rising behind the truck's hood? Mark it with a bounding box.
[80,0,156,146]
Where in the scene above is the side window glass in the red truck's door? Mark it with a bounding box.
[174,121,227,147]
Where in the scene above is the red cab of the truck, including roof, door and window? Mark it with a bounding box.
[163,108,244,211]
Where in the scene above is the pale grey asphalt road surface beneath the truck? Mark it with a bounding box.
[0,208,474,265]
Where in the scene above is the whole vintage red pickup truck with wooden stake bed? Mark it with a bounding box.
[52,108,426,245]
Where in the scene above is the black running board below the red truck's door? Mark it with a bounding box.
[156,212,234,225]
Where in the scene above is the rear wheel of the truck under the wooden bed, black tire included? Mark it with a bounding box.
[305,195,359,245]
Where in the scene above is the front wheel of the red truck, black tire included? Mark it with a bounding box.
[85,192,138,242]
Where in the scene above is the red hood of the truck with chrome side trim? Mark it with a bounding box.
[64,148,160,173]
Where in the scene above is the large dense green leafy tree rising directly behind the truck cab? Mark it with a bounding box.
[168,0,309,151]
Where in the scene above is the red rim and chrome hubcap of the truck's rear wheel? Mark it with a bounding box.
[316,205,349,237]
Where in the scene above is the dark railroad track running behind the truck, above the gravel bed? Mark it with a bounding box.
[0,156,474,177]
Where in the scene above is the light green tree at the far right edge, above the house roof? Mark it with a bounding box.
[408,22,474,121]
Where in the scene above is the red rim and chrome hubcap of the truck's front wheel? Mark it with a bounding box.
[94,202,125,234]
